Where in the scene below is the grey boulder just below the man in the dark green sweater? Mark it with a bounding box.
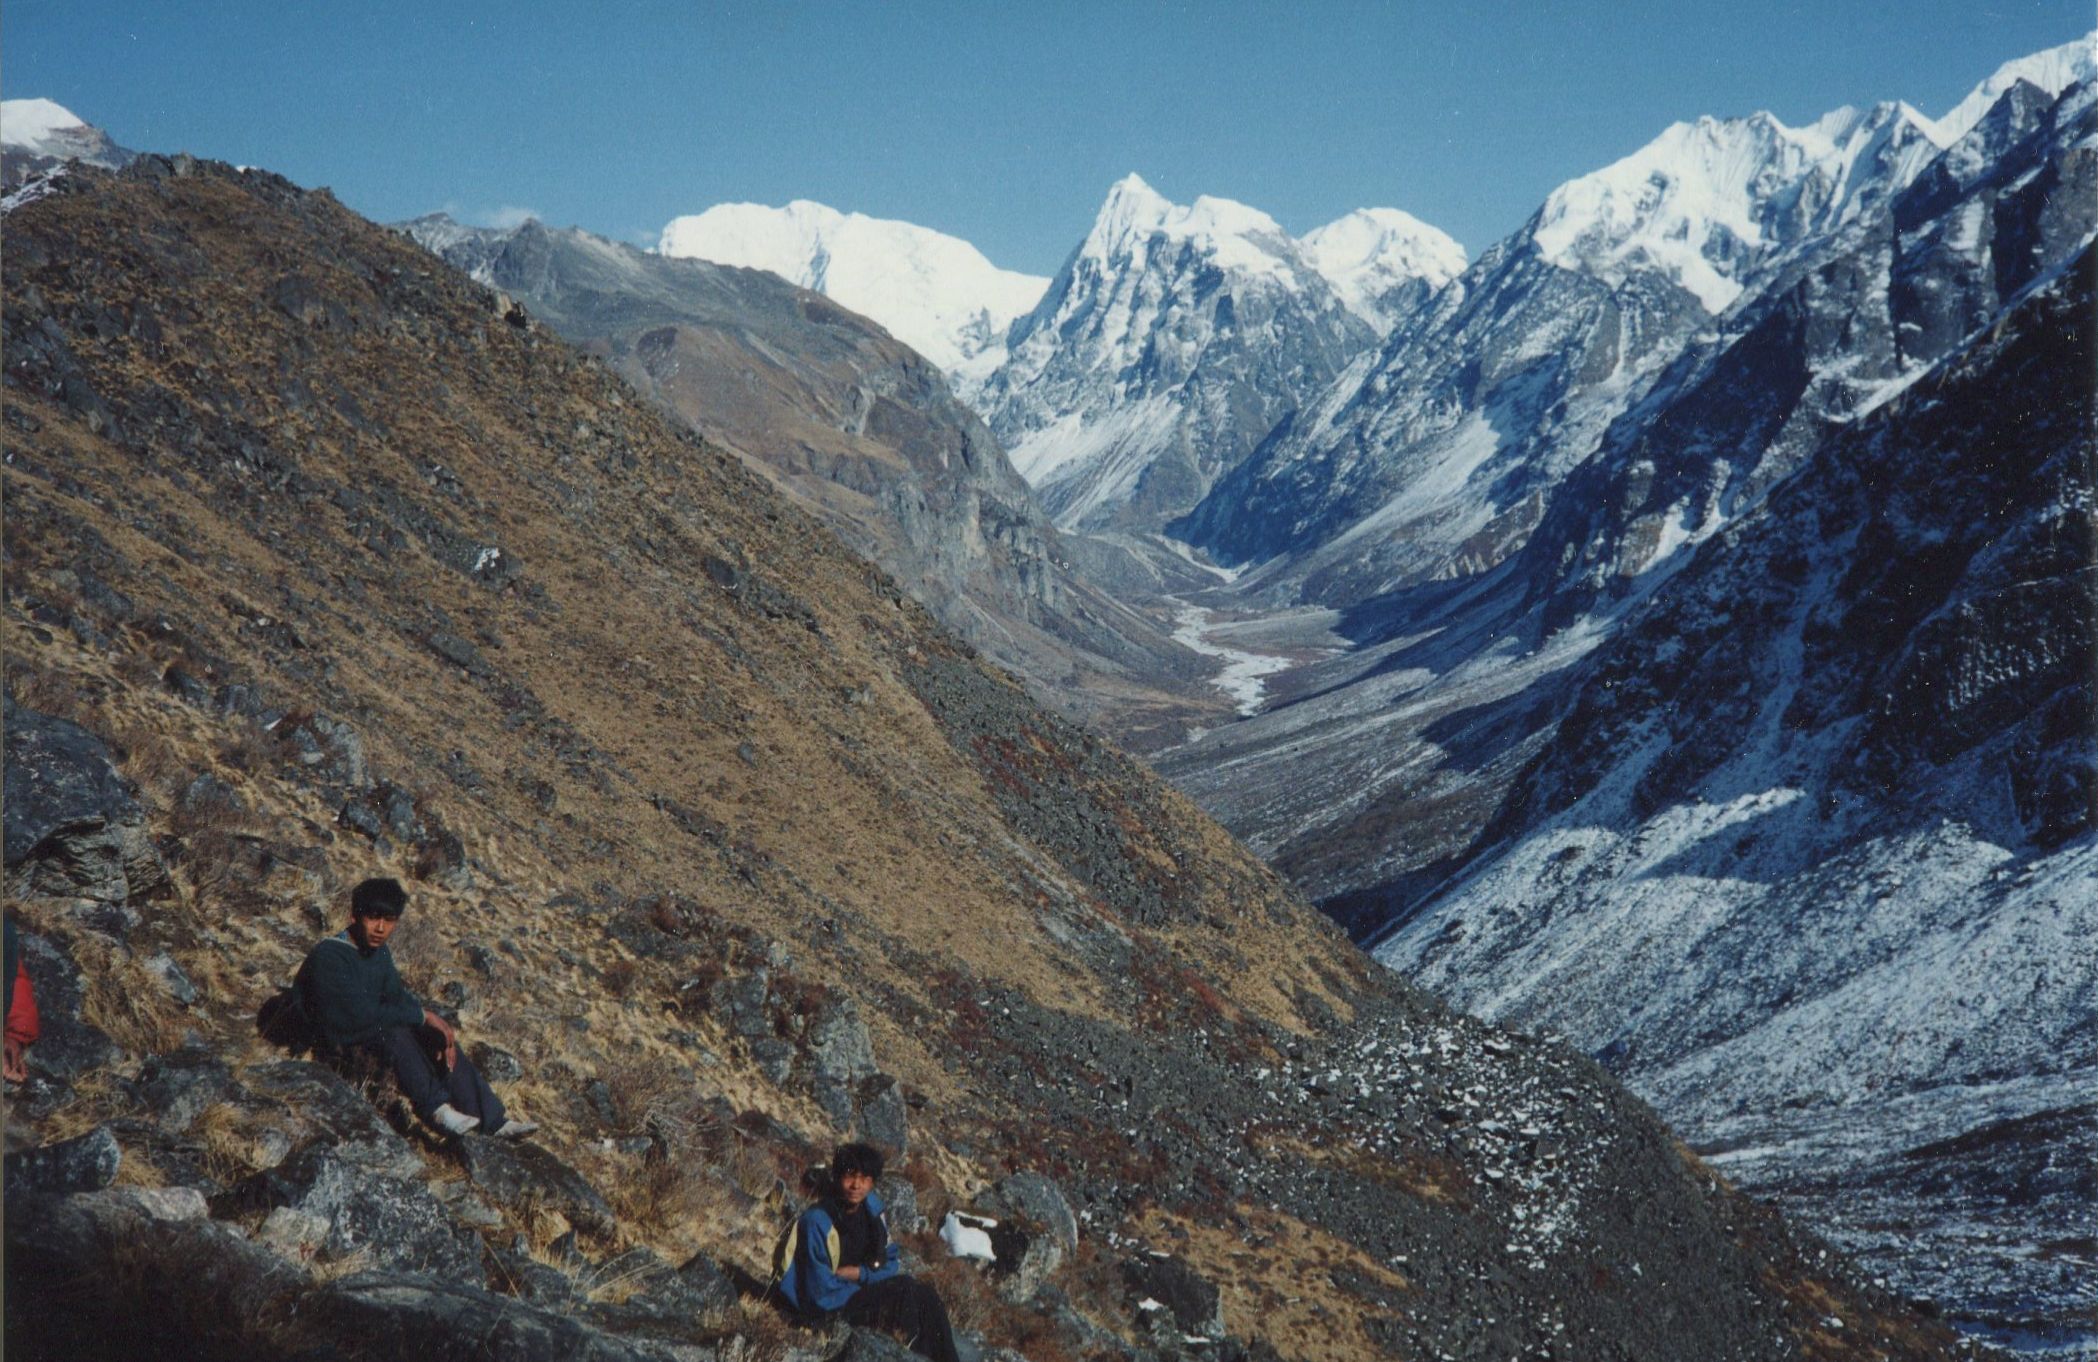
[212,1142,485,1286]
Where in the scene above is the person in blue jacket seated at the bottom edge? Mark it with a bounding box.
[780,1144,957,1362]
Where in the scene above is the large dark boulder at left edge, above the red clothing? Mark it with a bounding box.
[0,703,168,905]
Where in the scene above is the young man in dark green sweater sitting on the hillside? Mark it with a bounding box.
[292,879,539,1140]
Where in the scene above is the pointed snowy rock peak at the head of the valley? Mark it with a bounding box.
[976,174,1376,529]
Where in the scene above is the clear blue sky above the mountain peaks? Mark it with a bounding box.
[0,0,2094,273]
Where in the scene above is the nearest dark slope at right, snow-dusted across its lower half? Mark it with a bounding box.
[1378,236,2098,1356]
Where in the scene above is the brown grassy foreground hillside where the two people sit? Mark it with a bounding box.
[4,157,1947,1362]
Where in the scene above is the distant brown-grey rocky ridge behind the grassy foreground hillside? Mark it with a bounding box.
[403,216,1221,759]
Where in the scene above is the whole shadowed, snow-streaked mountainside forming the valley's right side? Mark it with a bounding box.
[1162,44,2098,1349]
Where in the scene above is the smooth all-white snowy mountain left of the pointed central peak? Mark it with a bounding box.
[657,199,1049,374]
